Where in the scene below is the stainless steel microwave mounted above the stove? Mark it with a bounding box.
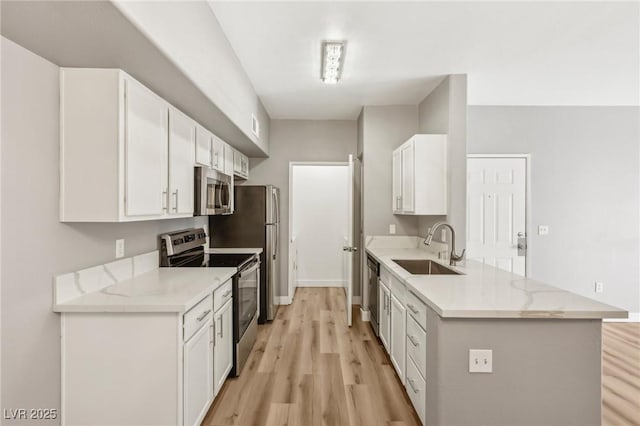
[194,167,233,216]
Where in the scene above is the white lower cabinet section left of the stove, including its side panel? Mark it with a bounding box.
[61,279,233,426]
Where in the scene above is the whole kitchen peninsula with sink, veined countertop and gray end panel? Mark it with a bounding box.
[367,237,627,425]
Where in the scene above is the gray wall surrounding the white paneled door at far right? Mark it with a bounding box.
[468,106,640,313]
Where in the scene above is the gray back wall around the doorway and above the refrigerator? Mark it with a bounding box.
[245,120,360,296]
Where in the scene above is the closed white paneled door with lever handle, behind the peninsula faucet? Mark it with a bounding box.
[467,157,527,275]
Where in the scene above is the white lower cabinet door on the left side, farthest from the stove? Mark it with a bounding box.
[183,311,214,426]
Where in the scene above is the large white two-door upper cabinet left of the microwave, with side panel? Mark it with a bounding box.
[60,68,194,222]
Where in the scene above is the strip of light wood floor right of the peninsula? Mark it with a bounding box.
[602,322,640,426]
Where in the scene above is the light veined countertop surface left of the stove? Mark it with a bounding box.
[53,268,237,313]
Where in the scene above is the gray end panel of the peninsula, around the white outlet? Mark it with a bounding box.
[425,309,602,426]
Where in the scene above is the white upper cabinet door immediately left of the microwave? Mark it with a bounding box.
[169,107,196,215]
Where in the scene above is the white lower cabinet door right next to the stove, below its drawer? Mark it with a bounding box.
[213,299,233,395]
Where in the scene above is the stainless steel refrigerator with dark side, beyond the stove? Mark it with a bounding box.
[209,185,280,324]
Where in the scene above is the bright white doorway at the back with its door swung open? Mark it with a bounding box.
[288,160,357,325]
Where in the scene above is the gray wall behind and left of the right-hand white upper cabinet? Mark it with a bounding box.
[362,105,418,236]
